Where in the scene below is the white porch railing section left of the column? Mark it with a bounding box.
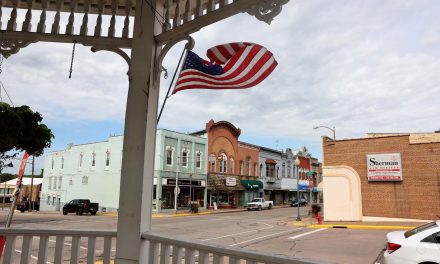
[0,228,116,264]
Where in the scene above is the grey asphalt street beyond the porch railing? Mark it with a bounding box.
[0,208,390,264]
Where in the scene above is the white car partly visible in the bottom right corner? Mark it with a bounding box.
[384,220,440,264]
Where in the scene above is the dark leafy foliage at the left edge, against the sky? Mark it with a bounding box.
[0,102,54,173]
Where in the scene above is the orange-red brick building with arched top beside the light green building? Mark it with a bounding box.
[192,119,263,208]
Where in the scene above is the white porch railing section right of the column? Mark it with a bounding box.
[142,233,324,264]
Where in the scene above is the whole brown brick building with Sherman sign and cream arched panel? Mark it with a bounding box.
[322,133,440,221]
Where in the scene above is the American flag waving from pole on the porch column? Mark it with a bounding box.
[173,42,278,94]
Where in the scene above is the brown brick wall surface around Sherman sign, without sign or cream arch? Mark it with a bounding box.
[323,135,440,219]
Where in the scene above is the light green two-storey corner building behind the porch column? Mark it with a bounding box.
[40,129,207,212]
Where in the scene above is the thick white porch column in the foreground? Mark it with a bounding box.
[116,0,159,264]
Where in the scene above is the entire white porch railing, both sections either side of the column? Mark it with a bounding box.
[0,228,324,264]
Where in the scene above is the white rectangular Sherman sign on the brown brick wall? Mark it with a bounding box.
[367,153,403,181]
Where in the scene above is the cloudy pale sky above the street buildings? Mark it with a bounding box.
[0,0,440,172]
